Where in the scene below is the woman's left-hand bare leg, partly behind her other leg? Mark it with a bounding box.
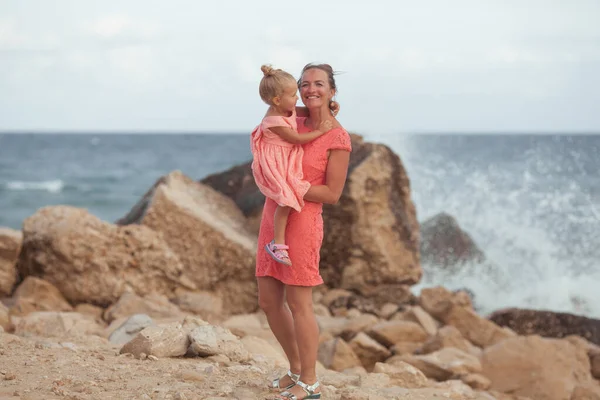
[257,276,300,387]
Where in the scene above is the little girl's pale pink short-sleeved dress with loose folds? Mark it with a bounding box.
[251,113,310,211]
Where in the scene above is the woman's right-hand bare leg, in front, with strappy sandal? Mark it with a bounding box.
[286,286,319,399]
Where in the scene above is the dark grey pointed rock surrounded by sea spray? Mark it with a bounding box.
[421,213,485,269]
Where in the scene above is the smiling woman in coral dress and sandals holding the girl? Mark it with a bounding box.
[256,64,352,400]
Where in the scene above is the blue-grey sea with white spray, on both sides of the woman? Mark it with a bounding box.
[0,133,600,318]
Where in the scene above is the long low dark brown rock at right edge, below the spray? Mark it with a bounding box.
[489,308,600,345]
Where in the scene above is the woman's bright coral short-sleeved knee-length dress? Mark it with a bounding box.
[256,118,352,286]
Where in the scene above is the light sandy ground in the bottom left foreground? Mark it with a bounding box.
[0,333,273,400]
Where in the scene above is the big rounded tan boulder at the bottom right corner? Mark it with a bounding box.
[481,336,592,400]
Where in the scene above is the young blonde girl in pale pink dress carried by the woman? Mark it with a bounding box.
[251,65,339,266]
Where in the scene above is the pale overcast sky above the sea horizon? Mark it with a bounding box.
[0,0,600,134]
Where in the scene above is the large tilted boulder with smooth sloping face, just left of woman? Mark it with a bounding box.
[117,171,257,313]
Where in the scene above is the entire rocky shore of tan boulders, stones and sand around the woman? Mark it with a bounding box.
[0,136,600,400]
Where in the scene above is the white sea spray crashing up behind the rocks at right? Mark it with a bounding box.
[368,135,600,318]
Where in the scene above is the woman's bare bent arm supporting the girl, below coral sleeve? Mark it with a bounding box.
[304,150,350,204]
